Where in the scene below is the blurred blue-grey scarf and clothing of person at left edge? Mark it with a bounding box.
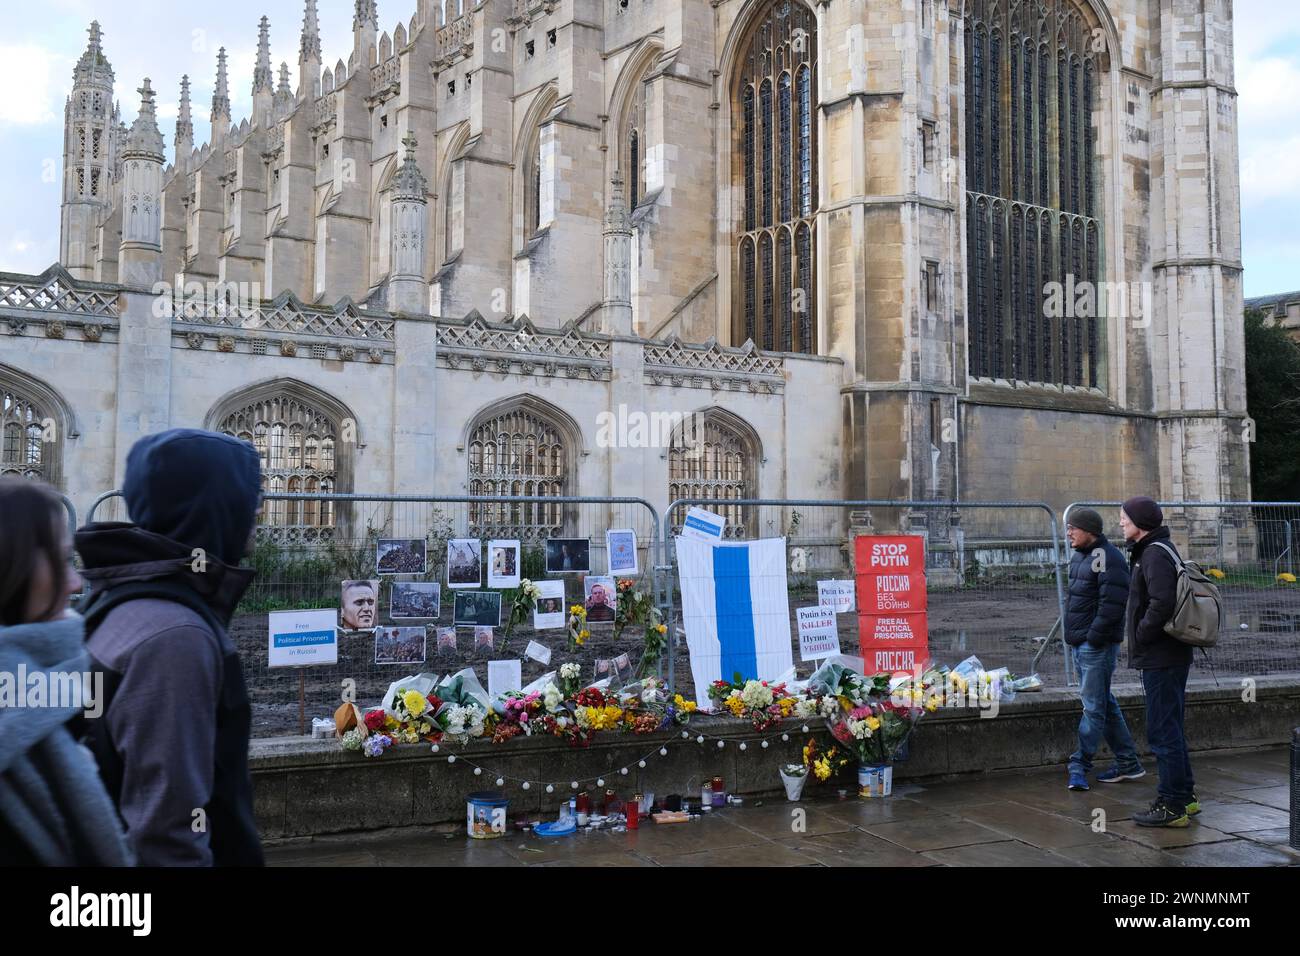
[0,614,131,866]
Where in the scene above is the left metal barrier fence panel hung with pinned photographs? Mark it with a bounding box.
[87,493,662,736]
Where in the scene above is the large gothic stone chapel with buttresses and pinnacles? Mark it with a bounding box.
[0,0,1249,535]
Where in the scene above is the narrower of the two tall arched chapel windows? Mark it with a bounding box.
[732,0,818,352]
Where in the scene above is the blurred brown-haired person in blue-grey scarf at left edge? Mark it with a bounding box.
[0,477,131,866]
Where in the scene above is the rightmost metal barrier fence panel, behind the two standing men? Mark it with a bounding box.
[1062,501,1300,678]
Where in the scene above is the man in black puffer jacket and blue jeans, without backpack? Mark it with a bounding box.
[1065,509,1147,790]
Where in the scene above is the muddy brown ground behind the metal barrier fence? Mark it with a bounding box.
[231,585,1300,736]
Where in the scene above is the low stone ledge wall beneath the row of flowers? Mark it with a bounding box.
[250,676,1300,839]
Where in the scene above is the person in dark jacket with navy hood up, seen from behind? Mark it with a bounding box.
[77,429,263,866]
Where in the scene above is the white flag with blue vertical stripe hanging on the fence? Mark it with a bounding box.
[677,537,794,708]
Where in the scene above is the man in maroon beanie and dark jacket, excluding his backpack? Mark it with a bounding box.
[1119,496,1201,827]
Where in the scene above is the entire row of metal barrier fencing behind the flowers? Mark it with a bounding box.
[78,492,1300,736]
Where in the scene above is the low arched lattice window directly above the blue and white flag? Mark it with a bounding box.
[668,411,758,537]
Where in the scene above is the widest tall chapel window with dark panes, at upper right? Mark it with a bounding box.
[965,0,1105,388]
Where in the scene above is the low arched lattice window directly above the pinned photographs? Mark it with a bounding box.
[468,405,569,541]
